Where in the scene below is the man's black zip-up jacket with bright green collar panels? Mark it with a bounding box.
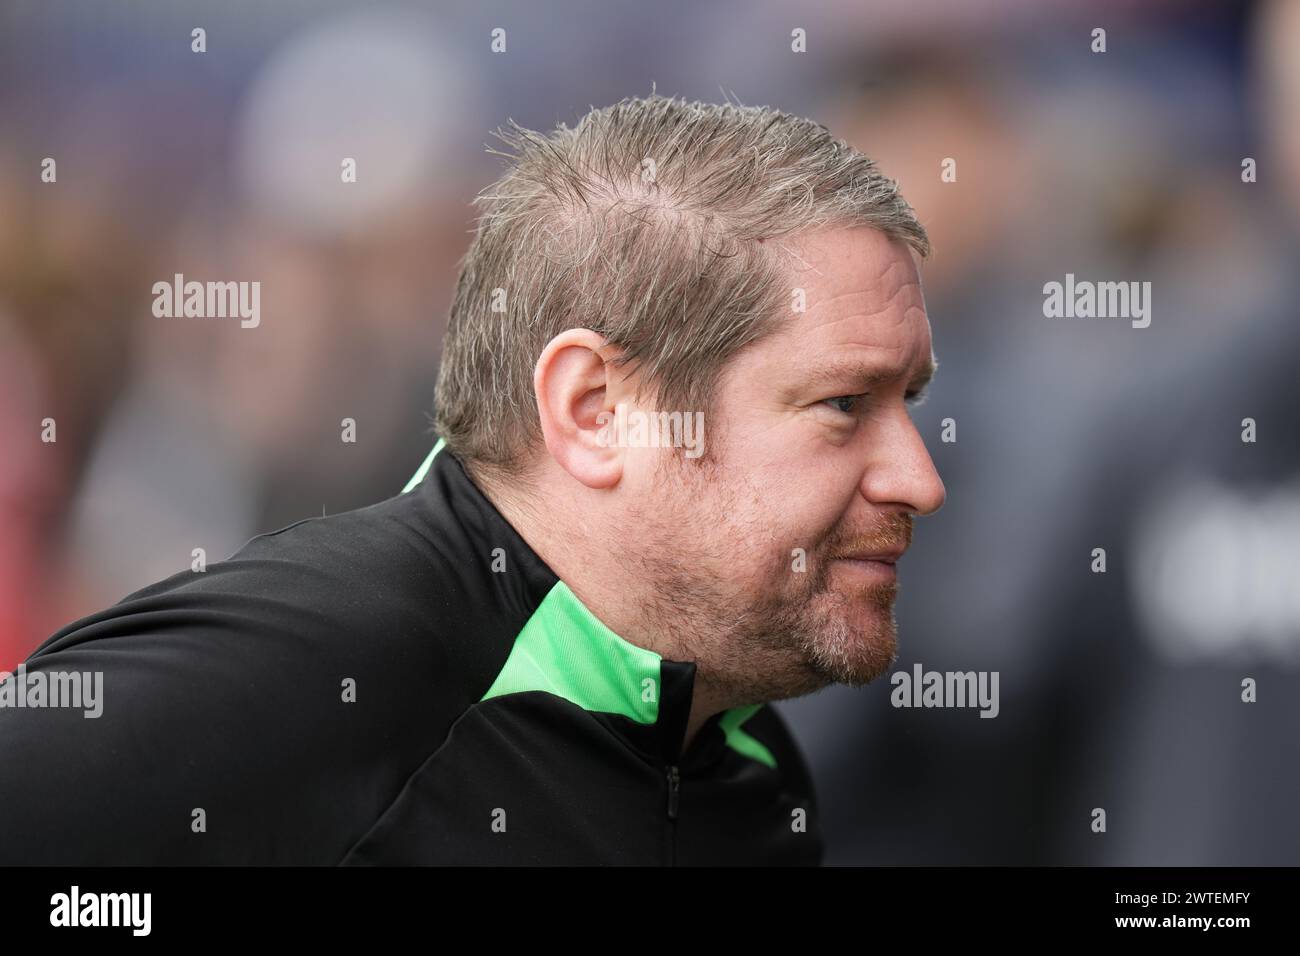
[0,442,823,865]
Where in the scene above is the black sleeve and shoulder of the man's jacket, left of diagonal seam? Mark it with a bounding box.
[0,492,543,864]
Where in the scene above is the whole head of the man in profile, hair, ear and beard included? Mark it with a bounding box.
[437,96,944,706]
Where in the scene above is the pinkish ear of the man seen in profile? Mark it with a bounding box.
[533,329,624,488]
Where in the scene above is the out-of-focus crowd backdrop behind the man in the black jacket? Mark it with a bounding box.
[0,0,1300,865]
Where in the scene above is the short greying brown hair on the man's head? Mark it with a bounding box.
[434,95,930,480]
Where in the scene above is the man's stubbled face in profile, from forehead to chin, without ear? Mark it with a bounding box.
[618,228,944,698]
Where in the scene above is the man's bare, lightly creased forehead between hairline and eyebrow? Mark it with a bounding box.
[770,228,931,375]
